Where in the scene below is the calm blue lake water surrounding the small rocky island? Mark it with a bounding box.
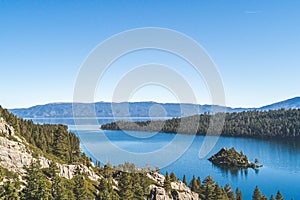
[31,119,300,199]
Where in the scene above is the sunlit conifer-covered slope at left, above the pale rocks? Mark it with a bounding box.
[0,106,87,163]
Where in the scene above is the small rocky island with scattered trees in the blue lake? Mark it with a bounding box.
[208,147,262,169]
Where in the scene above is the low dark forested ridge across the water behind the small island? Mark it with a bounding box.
[101,109,300,137]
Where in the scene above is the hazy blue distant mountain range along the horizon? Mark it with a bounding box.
[10,97,300,118]
